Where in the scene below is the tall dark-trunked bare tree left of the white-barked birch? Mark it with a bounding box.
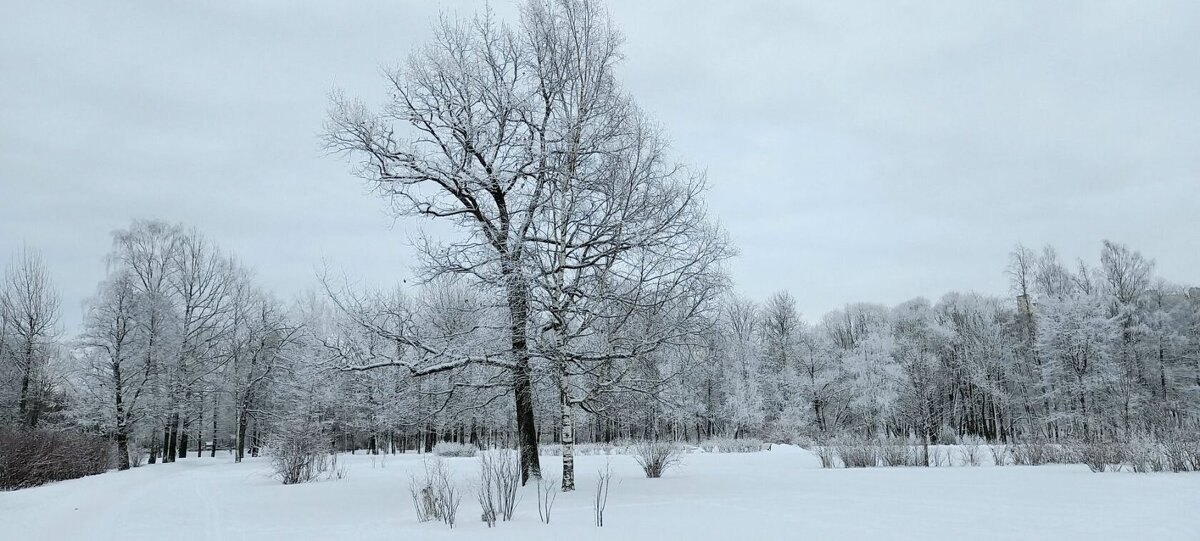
[325,5,554,480]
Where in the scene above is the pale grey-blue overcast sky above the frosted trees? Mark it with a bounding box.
[0,0,1200,327]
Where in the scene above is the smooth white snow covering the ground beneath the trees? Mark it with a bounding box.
[0,445,1200,541]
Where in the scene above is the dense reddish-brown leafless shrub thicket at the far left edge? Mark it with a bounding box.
[0,428,113,491]
